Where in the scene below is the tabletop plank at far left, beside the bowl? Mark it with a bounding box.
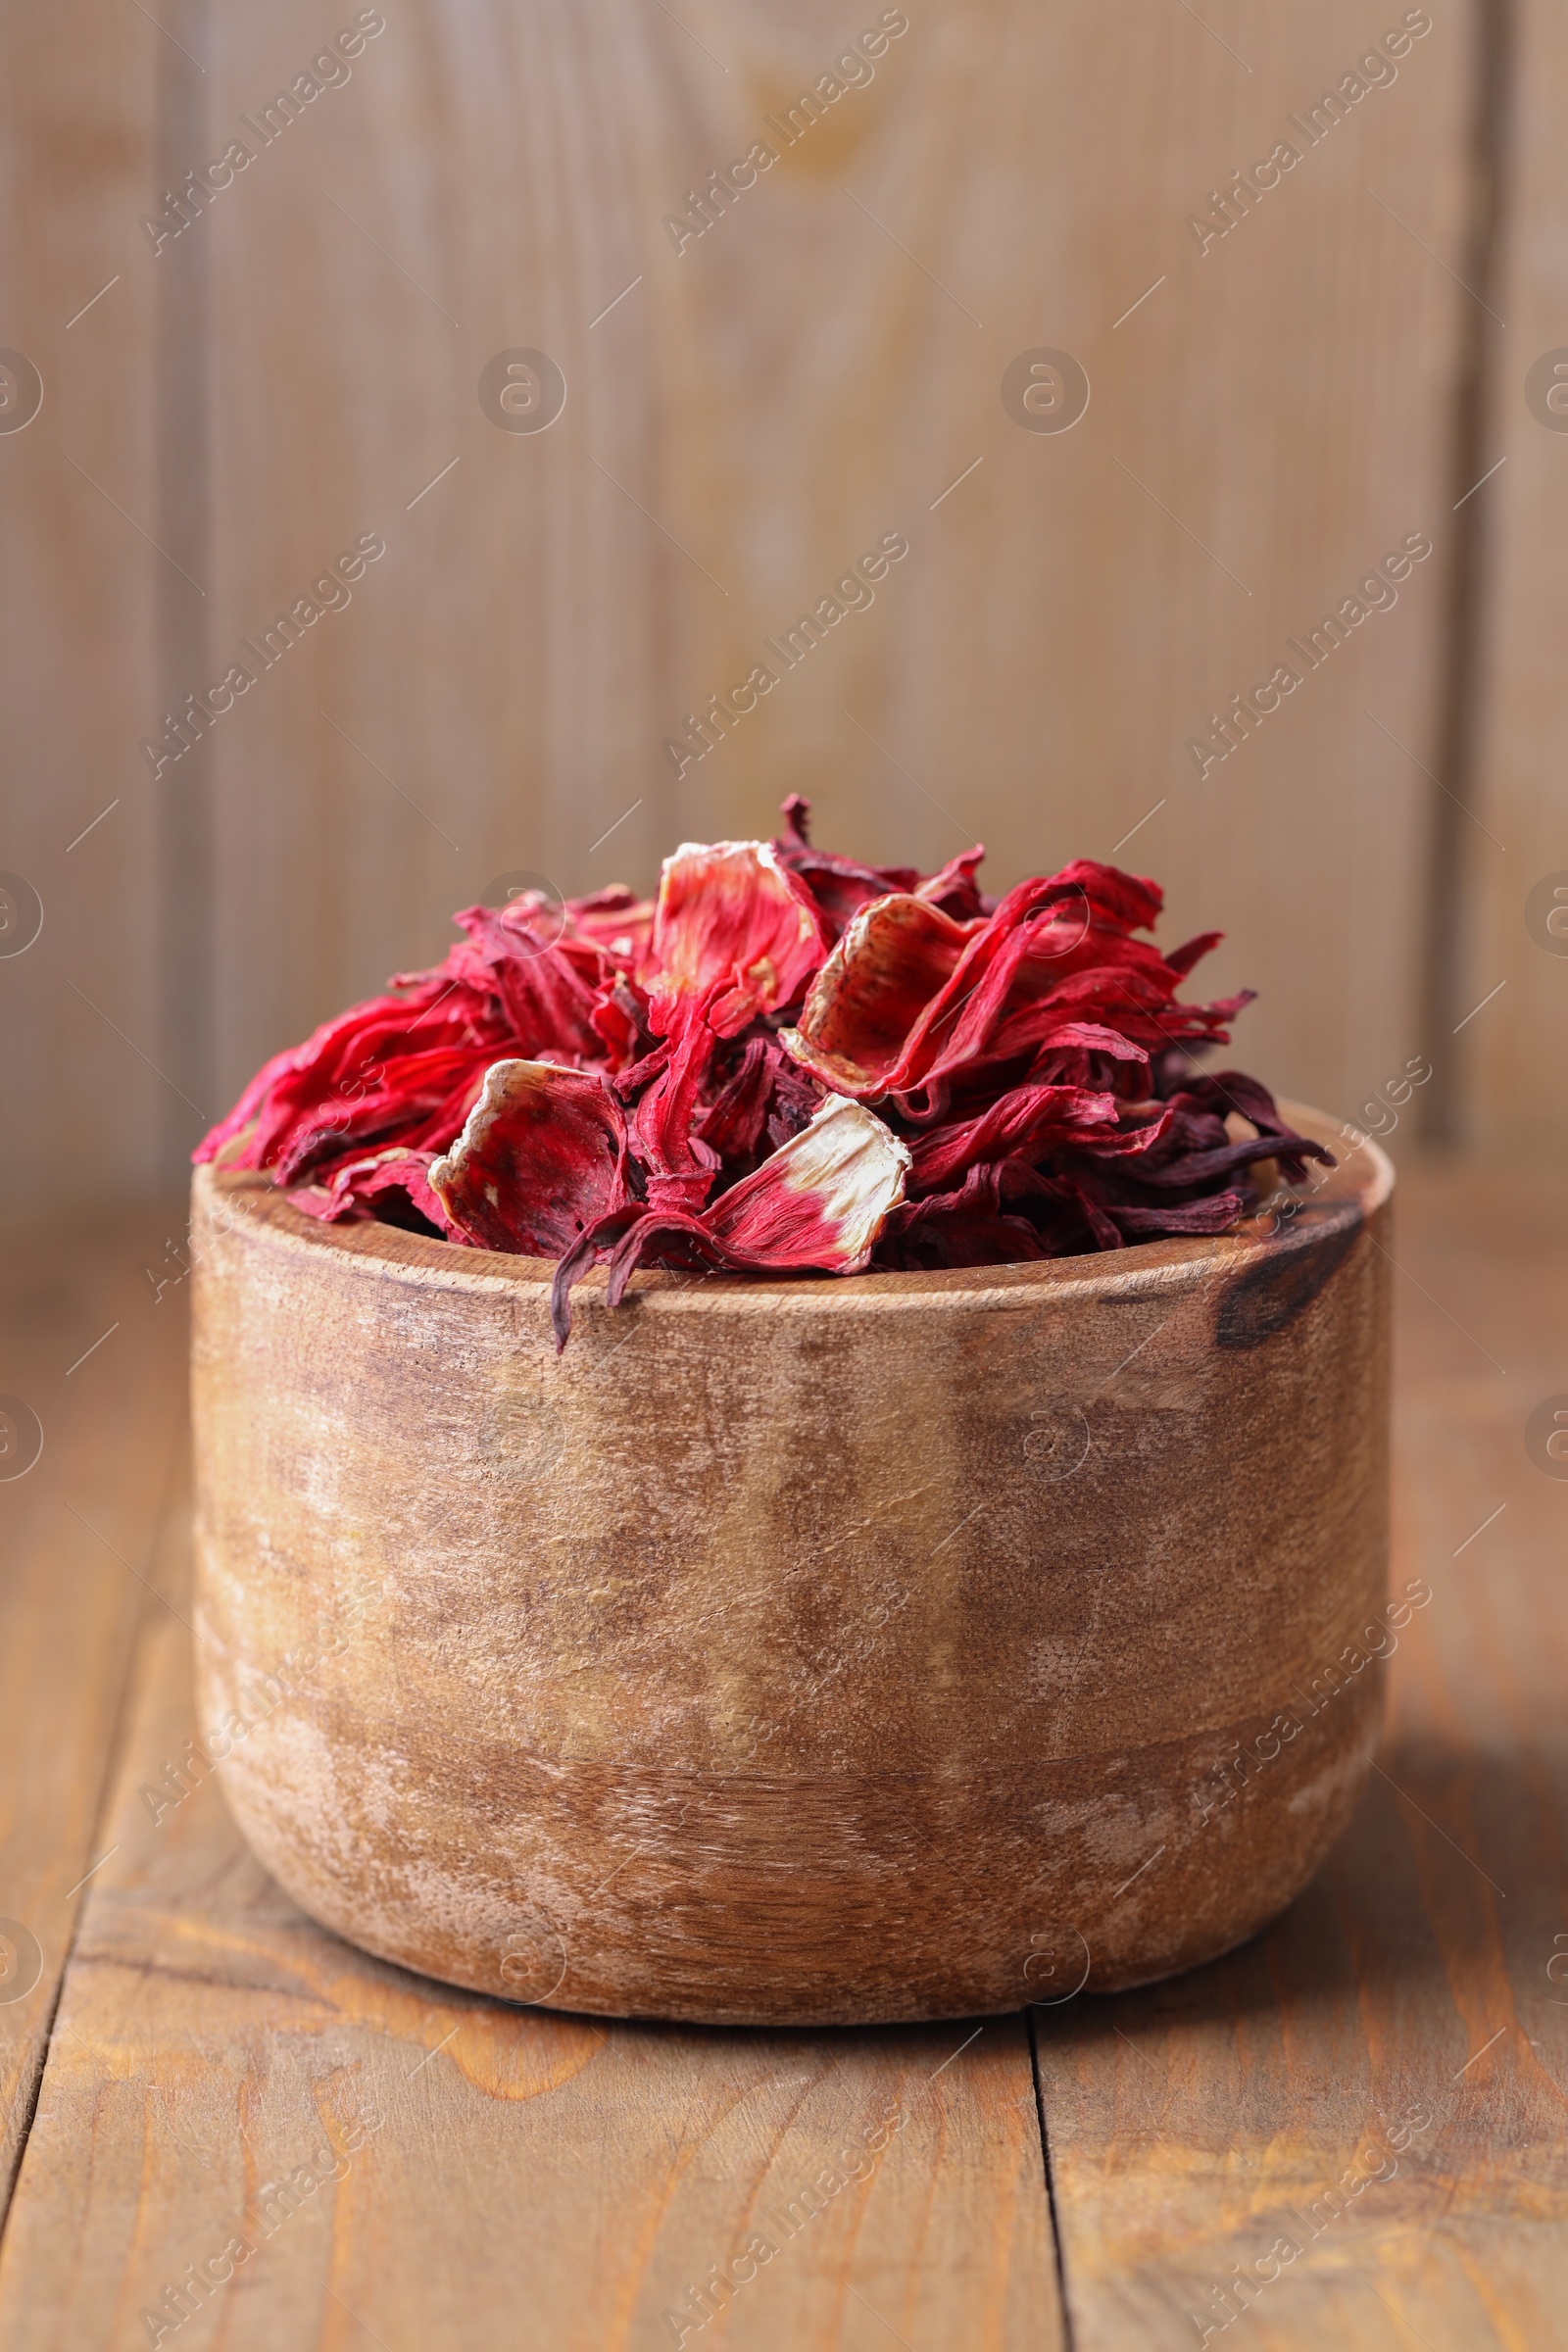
[0,1211,186,2209]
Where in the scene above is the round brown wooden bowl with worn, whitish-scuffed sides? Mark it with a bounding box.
[195,1107,1408,2025]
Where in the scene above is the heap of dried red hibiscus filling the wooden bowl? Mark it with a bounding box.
[195,798,1331,1346]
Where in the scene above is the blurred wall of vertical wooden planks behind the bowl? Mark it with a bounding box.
[0,0,1568,1201]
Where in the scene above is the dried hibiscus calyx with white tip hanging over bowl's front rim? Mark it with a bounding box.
[550,1094,909,1348]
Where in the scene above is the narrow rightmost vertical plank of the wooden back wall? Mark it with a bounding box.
[1455,0,1568,1141]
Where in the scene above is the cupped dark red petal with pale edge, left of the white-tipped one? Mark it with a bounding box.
[430,1060,627,1258]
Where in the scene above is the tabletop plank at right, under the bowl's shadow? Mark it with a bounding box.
[1037,1148,1568,2352]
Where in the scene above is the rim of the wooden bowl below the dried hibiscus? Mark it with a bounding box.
[190,1096,1394,1315]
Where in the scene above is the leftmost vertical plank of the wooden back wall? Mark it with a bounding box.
[0,0,167,1206]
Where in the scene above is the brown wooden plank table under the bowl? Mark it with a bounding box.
[0,1166,1568,2352]
